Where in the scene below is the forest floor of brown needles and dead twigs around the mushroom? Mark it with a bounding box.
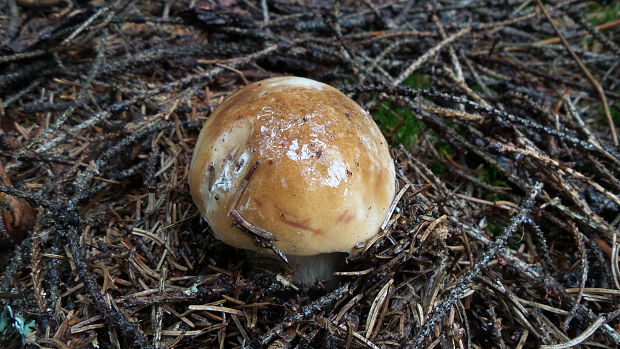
[0,0,620,348]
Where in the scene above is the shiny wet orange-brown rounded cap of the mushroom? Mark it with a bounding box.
[190,77,396,256]
